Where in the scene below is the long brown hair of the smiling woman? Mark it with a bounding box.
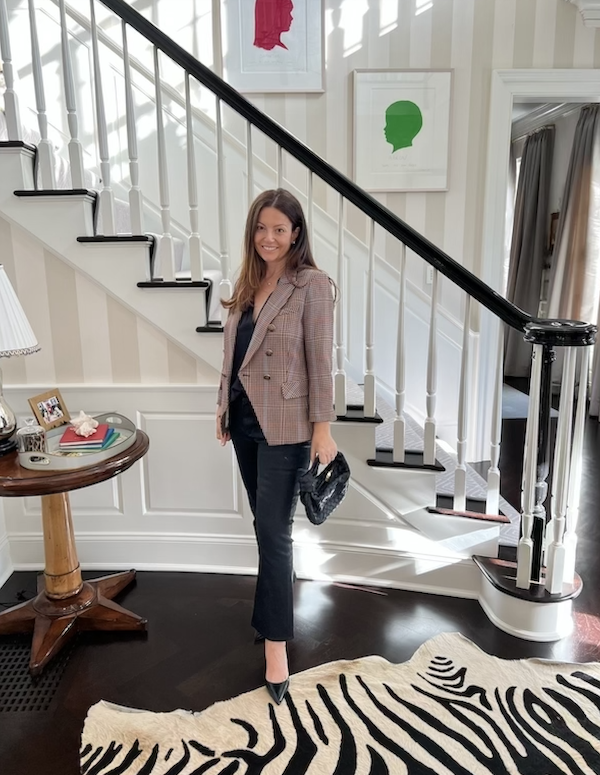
[222,188,317,311]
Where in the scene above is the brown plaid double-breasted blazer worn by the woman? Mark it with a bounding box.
[217,268,336,445]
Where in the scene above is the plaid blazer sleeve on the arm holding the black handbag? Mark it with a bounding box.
[303,272,336,422]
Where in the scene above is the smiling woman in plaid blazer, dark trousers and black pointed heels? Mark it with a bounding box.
[217,188,337,704]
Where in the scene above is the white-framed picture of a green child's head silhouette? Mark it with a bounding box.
[353,70,452,191]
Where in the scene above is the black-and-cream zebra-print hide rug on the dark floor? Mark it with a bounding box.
[81,633,600,775]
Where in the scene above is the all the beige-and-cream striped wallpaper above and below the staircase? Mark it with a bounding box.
[0,0,600,385]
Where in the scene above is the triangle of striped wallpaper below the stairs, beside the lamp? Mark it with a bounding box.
[0,218,214,387]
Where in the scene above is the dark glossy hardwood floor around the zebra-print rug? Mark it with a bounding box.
[0,420,600,775]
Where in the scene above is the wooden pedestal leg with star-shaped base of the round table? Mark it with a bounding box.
[0,493,147,675]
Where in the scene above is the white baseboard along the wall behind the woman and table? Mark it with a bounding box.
[11,533,480,599]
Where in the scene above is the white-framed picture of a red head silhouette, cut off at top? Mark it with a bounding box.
[222,0,325,93]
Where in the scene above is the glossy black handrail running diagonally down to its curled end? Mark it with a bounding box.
[100,0,596,346]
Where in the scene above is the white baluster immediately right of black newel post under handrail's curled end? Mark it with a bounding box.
[546,347,576,595]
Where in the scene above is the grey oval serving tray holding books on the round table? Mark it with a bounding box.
[19,412,136,471]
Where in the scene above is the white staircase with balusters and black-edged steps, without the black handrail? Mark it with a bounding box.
[0,0,595,640]
